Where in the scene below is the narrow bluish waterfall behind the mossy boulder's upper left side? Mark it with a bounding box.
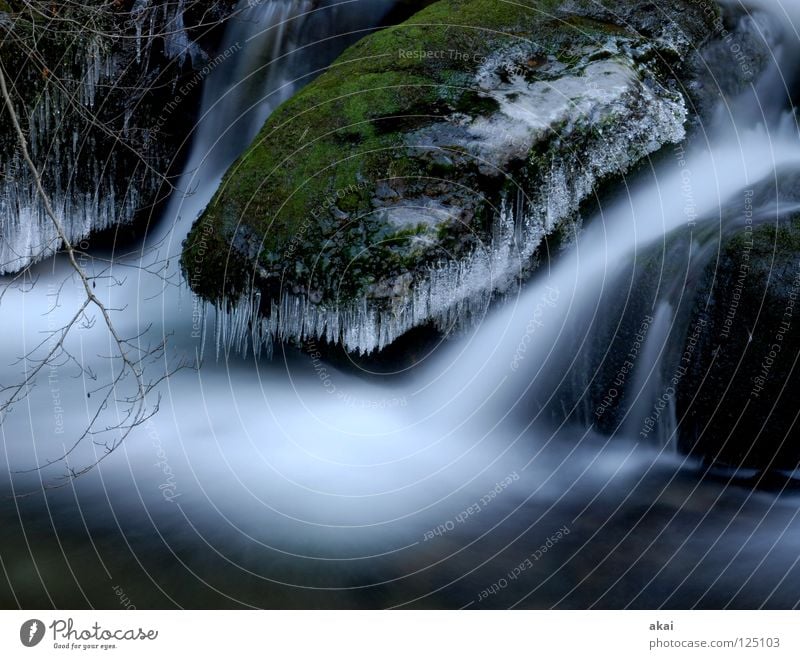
[147,0,394,253]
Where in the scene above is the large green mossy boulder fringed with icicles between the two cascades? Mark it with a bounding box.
[182,0,718,352]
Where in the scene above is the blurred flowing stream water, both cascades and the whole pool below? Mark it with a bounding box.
[0,2,800,608]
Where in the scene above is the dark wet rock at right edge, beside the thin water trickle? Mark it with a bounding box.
[676,171,800,470]
